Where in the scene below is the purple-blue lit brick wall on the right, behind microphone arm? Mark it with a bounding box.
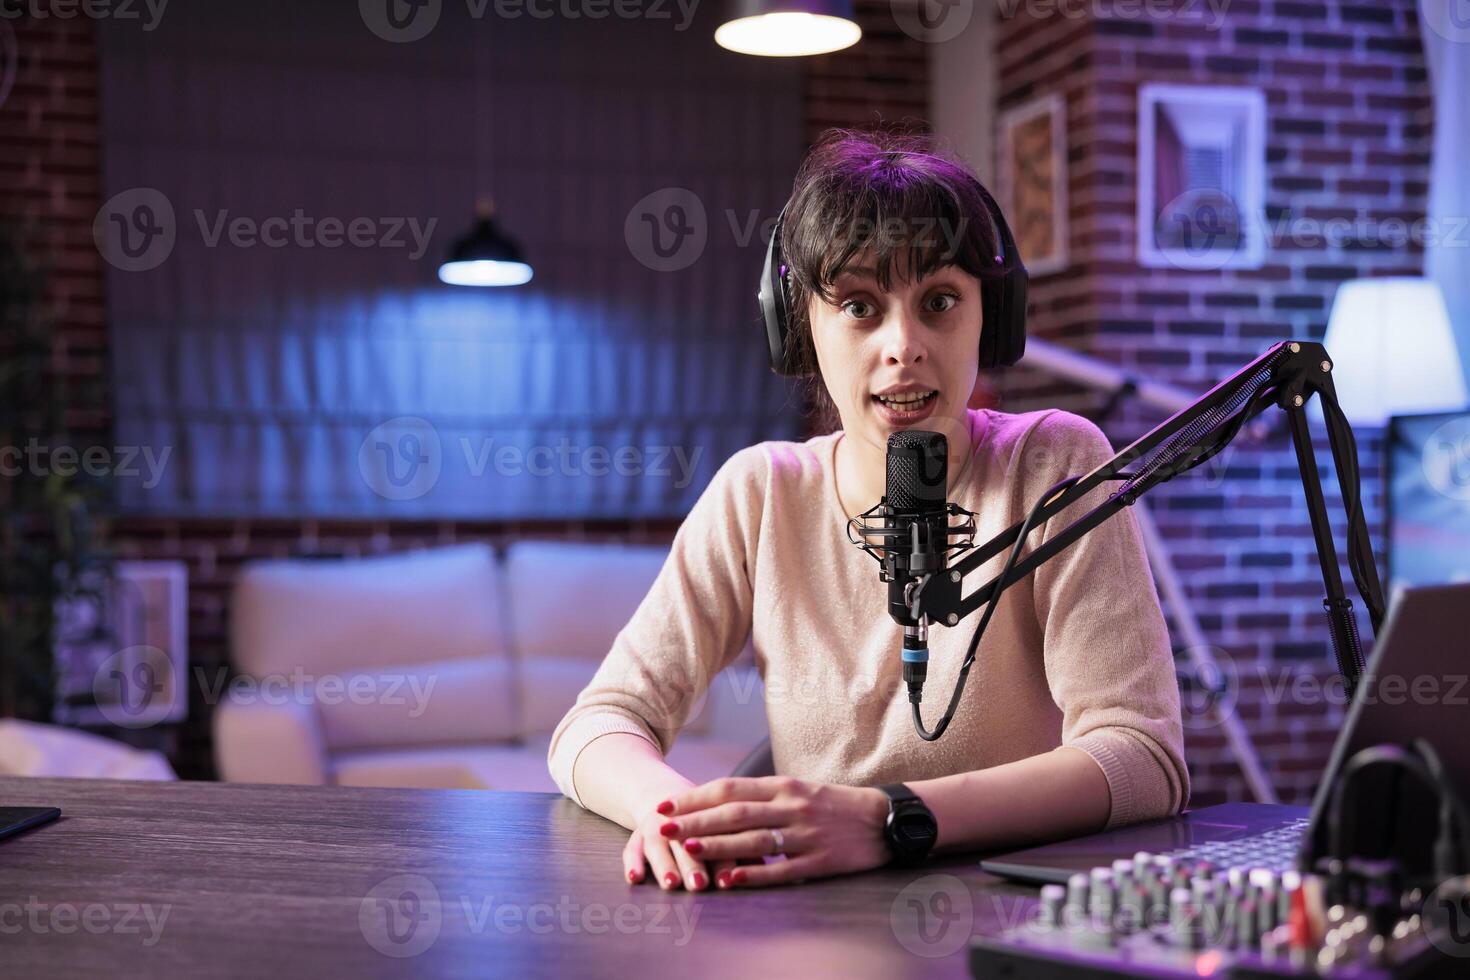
[1000,0,1430,804]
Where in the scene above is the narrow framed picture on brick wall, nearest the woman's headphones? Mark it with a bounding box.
[995,96,1067,276]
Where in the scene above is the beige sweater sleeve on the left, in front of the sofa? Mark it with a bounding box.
[547,445,769,805]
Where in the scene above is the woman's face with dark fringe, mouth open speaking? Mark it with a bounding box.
[809,260,982,461]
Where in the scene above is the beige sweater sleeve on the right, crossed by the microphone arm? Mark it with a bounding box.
[1017,411,1189,827]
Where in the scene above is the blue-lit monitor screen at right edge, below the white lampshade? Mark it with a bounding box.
[1388,411,1470,589]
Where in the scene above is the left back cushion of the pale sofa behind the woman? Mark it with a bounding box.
[231,544,506,677]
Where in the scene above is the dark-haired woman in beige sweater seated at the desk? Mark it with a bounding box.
[548,132,1189,890]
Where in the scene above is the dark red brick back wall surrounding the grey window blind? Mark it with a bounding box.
[0,7,928,779]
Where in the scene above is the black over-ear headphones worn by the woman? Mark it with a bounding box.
[756,176,1028,375]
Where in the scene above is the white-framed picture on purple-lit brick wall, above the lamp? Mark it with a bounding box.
[1138,85,1266,269]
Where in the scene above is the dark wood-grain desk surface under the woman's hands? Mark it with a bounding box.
[0,777,1029,980]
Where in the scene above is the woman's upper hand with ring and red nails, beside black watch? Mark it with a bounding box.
[659,776,889,887]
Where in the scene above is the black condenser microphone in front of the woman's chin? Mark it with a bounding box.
[882,429,950,702]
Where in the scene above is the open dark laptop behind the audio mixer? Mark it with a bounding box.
[980,583,1470,884]
